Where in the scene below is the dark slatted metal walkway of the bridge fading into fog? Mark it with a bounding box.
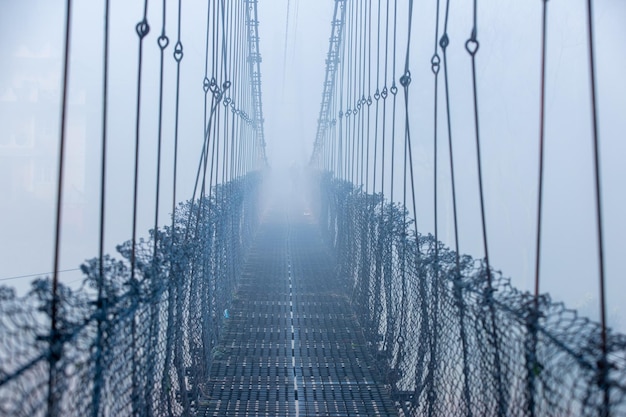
[199,200,397,416]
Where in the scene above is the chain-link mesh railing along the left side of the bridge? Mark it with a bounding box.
[0,174,259,416]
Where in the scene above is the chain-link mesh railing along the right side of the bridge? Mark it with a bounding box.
[319,171,626,416]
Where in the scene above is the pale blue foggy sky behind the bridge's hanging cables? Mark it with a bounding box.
[0,0,626,331]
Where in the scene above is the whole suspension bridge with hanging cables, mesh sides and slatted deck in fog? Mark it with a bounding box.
[0,0,626,417]
